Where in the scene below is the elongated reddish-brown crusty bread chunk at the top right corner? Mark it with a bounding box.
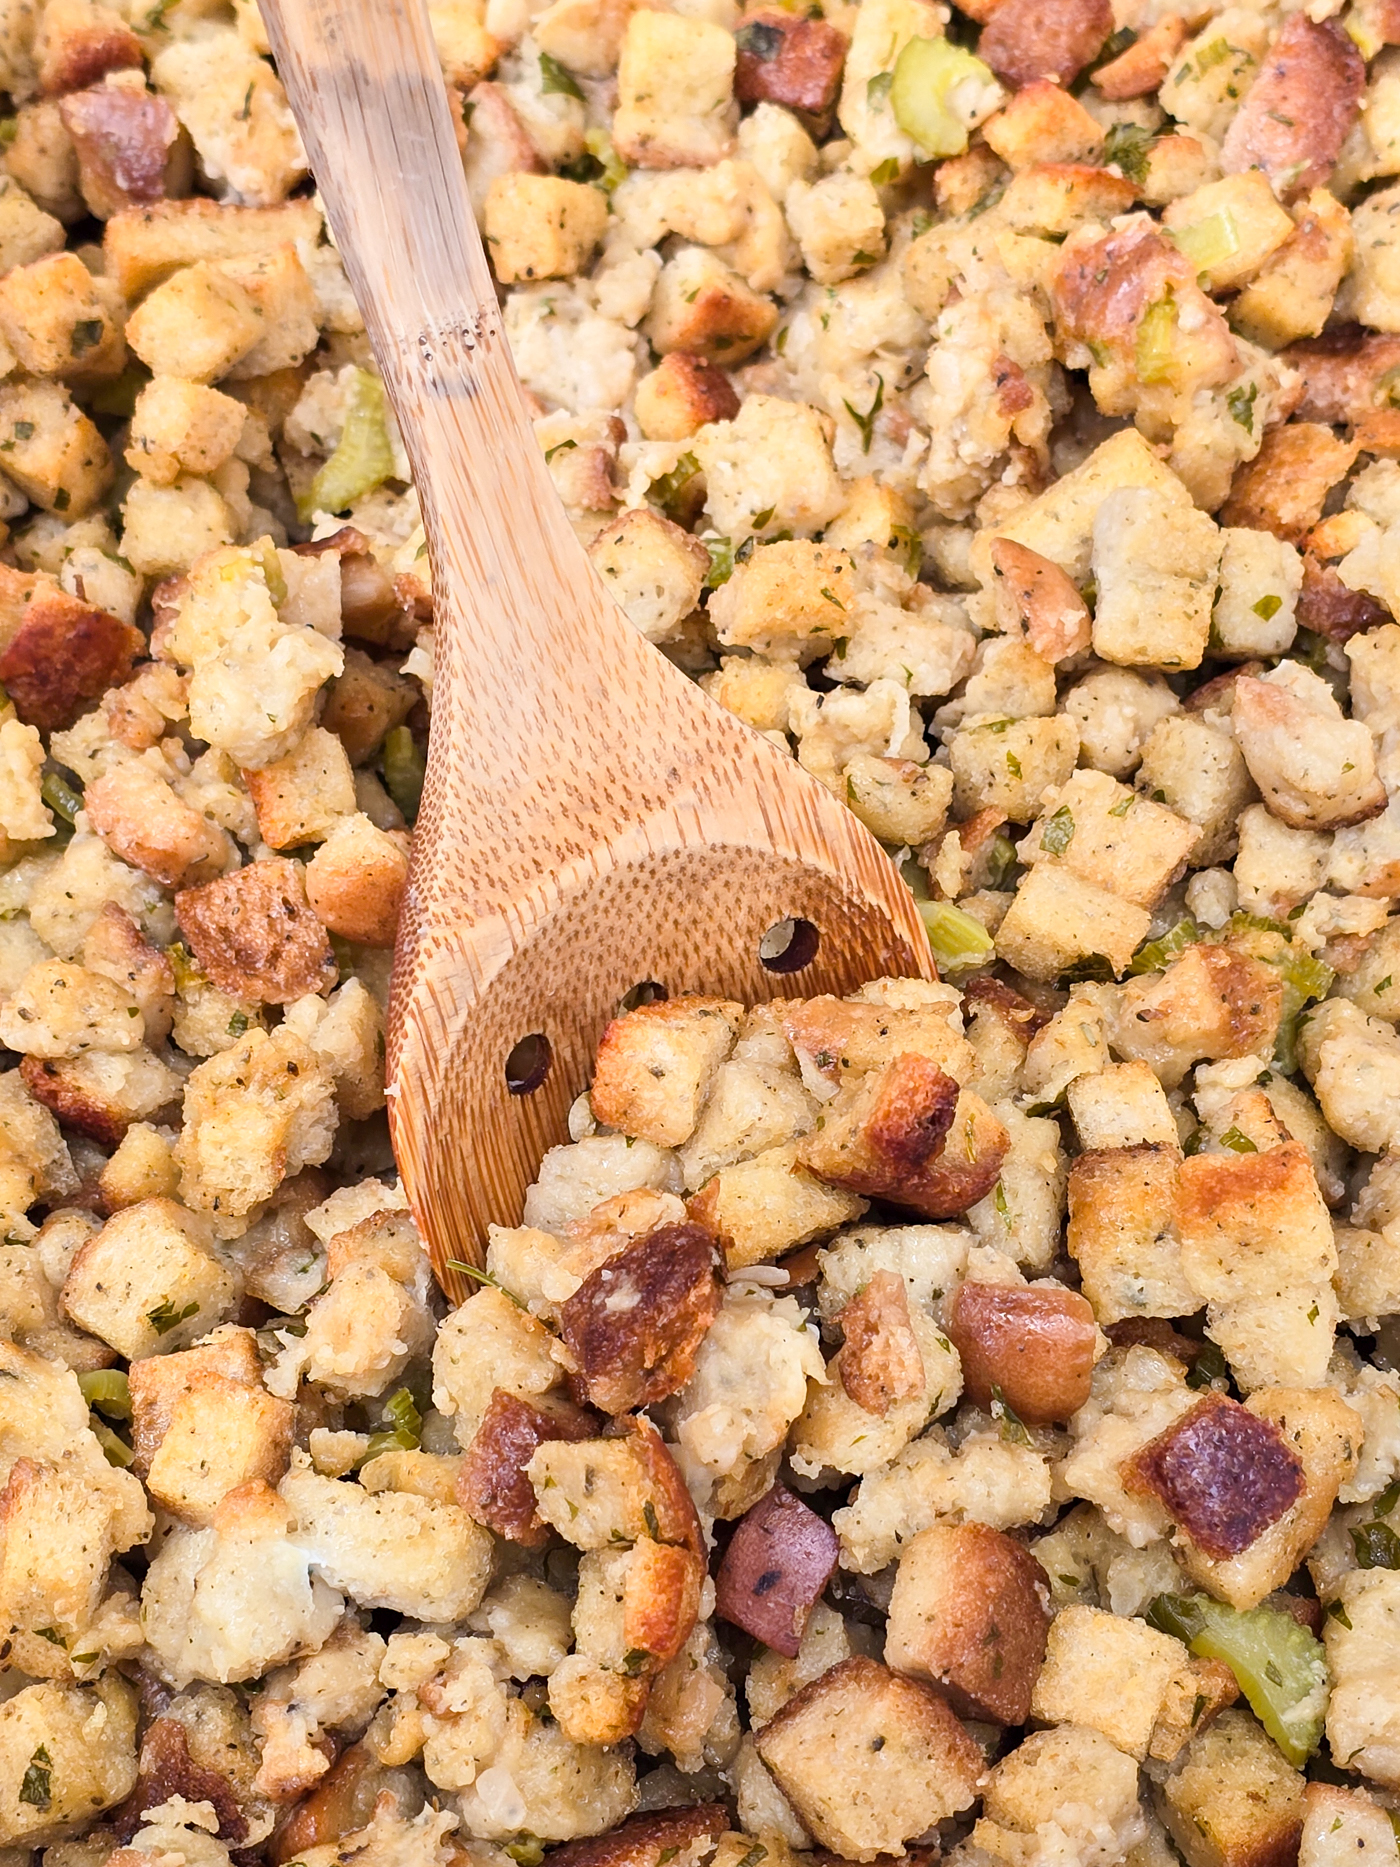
[1221,13,1366,200]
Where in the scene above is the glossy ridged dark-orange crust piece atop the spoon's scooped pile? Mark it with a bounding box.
[797,1055,1008,1219]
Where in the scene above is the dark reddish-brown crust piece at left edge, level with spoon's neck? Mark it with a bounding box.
[0,573,146,732]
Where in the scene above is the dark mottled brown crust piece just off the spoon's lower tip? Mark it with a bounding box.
[560,1221,722,1413]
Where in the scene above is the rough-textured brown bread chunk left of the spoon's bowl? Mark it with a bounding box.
[175,857,336,1004]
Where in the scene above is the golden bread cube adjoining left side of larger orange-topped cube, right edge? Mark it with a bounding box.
[1068,1143,1198,1324]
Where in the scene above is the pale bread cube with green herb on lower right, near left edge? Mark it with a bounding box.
[63,1199,239,1359]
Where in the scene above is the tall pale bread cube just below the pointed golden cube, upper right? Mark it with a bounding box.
[1092,487,1221,668]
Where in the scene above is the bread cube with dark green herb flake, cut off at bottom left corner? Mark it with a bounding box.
[0,1673,136,1848]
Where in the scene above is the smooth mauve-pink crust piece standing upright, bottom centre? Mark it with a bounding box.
[715,1484,840,1660]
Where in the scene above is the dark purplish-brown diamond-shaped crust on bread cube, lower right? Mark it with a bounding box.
[1124,1395,1303,1559]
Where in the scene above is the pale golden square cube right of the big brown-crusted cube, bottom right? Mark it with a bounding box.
[1030,1604,1187,1762]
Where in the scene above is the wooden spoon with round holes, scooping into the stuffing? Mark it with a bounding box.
[261,0,935,1301]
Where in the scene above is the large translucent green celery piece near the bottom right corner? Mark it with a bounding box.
[1146,1594,1327,1768]
